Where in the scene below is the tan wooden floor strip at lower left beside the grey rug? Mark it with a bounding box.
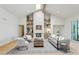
[0,40,17,54]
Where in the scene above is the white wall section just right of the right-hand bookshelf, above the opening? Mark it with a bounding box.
[51,15,64,34]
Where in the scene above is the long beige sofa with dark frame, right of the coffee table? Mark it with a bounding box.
[48,35,70,52]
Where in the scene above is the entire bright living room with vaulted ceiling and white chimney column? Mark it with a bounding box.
[0,4,79,55]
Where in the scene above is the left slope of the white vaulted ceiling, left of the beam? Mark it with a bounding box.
[0,4,36,18]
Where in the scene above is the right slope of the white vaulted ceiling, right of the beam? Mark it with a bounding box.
[46,4,79,18]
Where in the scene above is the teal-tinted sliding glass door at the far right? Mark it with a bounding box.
[71,21,79,41]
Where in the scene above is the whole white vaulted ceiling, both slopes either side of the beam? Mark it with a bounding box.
[0,4,79,18]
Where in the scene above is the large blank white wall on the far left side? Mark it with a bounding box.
[0,8,18,44]
